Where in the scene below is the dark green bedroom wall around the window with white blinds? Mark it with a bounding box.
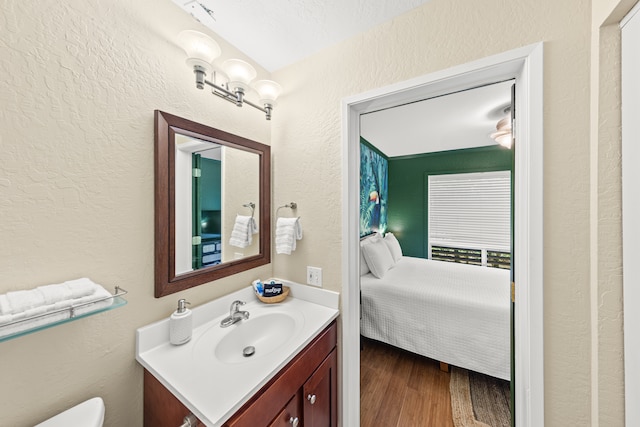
[387,146,513,258]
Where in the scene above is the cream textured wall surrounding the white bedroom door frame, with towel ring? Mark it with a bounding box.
[272,0,591,426]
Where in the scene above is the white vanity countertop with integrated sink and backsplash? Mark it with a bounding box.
[135,282,339,427]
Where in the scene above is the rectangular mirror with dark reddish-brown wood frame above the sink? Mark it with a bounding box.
[154,110,271,298]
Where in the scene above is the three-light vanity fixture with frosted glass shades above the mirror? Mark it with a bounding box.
[178,30,282,120]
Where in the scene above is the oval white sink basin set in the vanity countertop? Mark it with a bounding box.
[193,305,304,364]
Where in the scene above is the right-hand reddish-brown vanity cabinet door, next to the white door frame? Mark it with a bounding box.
[302,349,338,427]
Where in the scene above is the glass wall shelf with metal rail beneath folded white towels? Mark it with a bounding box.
[0,286,127,342]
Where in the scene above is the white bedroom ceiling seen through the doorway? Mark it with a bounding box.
[360,81,512,157]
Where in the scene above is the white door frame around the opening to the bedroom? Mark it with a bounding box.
[340,42,544,427]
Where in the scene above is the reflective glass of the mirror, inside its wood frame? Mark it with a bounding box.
[175,134,260,275]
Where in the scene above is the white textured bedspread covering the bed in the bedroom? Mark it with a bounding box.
[360,257,511,380]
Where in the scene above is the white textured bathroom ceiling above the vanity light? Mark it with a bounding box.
[173,0,428,71]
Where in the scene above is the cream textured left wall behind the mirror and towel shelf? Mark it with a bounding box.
[0,0,271,427]
